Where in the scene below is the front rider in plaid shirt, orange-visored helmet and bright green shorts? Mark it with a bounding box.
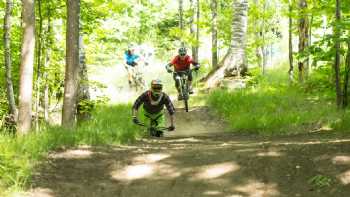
[132,79,175,136]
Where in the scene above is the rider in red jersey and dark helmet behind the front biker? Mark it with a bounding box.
[166,47,200,100]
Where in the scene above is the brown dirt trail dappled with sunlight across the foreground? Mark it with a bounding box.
[23,108,350,197]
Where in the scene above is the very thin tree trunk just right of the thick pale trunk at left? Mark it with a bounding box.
[35,0,43,131]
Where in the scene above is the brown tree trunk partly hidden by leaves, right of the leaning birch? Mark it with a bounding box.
[298,0,309,82]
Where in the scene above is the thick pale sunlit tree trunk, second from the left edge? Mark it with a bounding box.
[17,0,35,134]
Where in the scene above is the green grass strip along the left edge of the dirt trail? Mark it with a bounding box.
[0,105,140,196]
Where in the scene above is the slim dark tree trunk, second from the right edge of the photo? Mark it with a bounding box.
[334,0,342,107]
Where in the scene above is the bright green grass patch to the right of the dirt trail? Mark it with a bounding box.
[207,68,350,135]
